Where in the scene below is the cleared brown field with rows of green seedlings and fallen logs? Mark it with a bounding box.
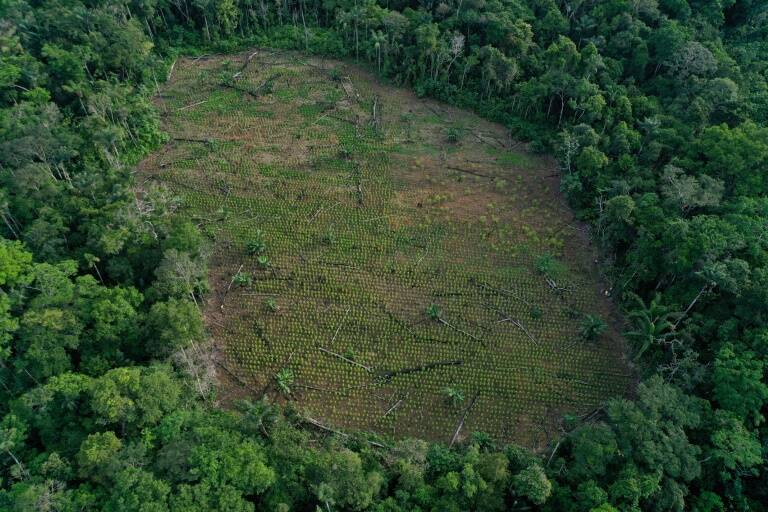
[140,50,633,446]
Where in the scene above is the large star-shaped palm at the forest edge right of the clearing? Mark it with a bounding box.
[624,293,681,360]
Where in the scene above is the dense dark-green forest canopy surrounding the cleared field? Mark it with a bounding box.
[0,0,768,512]
